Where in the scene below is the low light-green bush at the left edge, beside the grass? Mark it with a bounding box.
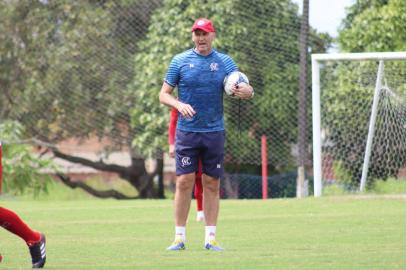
[0,121,55,196]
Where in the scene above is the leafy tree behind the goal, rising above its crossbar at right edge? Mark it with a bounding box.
[322,0,406,185]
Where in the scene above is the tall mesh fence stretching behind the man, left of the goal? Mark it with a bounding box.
[0,0,329,198]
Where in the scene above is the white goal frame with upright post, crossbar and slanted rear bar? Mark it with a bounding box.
[312,52,406,197]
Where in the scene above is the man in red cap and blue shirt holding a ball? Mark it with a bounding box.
[159,18,253,251]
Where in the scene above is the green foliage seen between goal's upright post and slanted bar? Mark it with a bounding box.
[321,62,376,186]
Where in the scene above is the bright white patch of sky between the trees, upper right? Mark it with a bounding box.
[293,0,356,37]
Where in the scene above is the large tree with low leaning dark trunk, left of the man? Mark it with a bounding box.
[0,0,162,198]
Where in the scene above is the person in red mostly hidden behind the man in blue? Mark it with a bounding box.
[168,108,204,221]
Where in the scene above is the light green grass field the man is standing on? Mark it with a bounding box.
[0,195,406,270]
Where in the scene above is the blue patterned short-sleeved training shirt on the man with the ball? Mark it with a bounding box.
[165,49,238,132]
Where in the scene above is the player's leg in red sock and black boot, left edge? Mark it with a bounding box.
[0,207,46,268]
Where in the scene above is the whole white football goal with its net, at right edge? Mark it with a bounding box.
[312,53,406,196]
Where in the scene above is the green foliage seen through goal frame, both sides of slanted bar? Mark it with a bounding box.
[321,61,406,186]
